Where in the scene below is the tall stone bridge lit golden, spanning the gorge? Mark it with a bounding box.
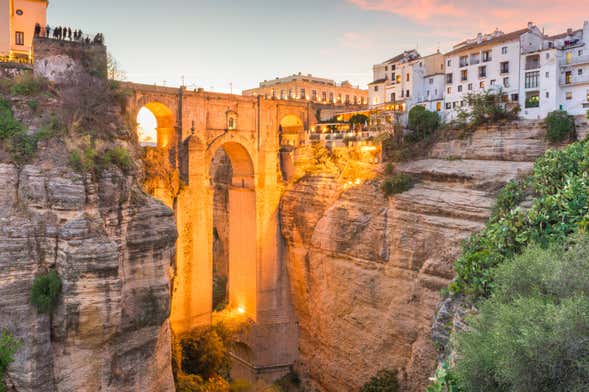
[126,83,315,378]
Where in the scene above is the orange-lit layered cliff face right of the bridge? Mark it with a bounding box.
[281,123,547,391]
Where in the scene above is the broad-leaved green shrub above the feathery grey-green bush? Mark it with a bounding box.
[450,142,589,297]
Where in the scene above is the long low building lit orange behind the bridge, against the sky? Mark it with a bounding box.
[242,72,368,105]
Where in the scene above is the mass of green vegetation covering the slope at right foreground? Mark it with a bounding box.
[430,136,589,391]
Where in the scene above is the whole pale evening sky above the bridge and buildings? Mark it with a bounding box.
[48,0,589,93]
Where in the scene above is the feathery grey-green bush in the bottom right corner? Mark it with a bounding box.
[454,239,589,392]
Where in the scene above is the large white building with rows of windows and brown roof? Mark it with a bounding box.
[444,23,543,120]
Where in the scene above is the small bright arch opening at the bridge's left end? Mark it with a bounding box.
[137,102,175,148]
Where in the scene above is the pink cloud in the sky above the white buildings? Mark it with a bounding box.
[346,0,589,38]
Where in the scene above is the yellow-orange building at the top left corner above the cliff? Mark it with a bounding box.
[0,0,48,60]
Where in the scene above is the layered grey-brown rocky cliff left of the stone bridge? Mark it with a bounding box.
[0,45,176,392]
